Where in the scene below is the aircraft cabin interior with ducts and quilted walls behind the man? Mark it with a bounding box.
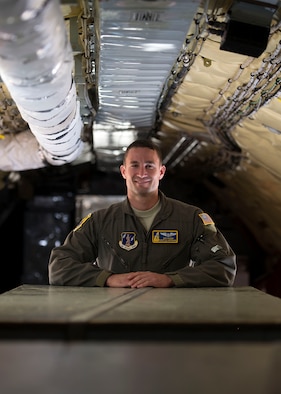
[0,0,281,297]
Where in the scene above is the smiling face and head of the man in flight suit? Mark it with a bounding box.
[120,148,166,195]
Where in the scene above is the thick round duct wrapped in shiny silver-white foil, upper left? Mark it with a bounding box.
[0,0,83,168]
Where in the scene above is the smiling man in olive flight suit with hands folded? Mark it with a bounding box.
[49,140,236,288]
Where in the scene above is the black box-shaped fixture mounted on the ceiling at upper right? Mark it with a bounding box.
[220,0,278,57]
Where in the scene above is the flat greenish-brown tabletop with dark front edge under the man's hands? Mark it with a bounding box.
[0,285,281,341]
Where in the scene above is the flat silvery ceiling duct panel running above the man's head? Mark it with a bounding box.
[93,0,198,169]
